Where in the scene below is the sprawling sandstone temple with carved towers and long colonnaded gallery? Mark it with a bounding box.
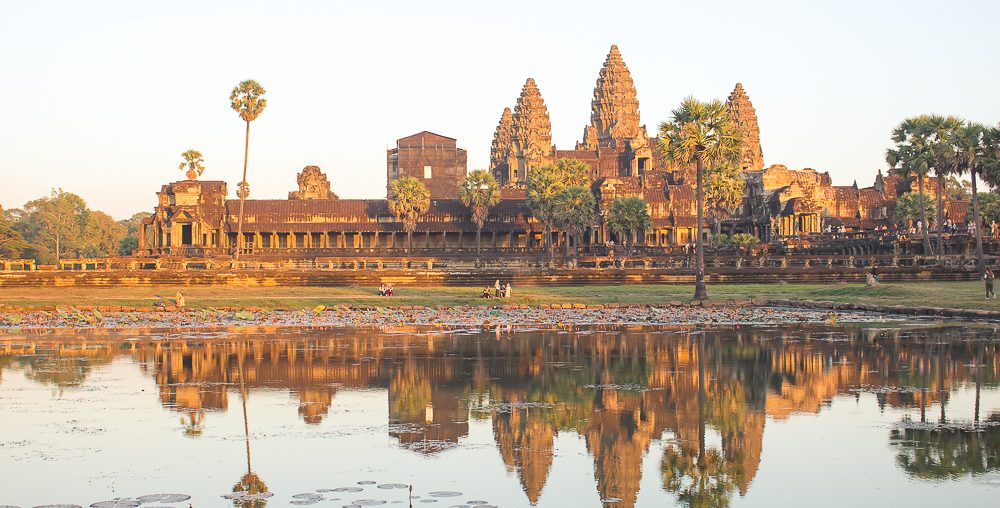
[139,46,967,257]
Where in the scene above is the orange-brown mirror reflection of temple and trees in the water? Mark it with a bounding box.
[0,327,1000,507]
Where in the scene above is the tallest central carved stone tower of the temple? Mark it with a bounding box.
[578,46,648,150]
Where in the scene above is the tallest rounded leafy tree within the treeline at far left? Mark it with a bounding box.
[22,189,87,262]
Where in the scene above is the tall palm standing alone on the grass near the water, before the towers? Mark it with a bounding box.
[659,97,743,300]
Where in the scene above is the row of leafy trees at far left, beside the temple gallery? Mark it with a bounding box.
[0,189,151,264]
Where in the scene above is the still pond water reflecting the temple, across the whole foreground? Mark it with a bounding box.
[0,325,1000,508]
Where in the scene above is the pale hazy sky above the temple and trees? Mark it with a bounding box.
[0,0,1000,218]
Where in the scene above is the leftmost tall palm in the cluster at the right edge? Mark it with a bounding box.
[885,115,940,254]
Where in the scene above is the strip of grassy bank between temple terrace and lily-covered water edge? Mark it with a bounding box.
[0,282,1000,310]
